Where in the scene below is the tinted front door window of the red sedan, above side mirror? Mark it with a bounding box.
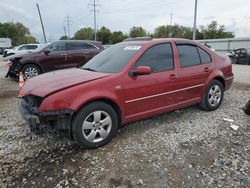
[135,44,174,72]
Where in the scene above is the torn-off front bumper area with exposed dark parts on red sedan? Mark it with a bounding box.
[18,96,74,132]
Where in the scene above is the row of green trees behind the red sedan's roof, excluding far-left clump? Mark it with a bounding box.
[60,21,234,44]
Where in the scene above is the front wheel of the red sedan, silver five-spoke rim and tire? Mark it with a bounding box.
[72,101,118,148]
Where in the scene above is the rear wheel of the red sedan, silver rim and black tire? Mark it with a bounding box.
[199,80,224,111]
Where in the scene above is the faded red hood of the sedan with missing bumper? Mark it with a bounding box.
[22,68,110,97]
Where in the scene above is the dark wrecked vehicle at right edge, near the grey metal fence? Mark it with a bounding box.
[227,48,250,65]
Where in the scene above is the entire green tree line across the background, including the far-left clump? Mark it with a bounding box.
[0,21,234,46]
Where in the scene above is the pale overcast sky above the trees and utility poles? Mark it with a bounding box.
[0,0,250,42]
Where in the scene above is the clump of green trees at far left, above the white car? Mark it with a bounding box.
[0,22,36,46]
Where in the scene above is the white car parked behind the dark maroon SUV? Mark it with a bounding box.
[3,44,41,57]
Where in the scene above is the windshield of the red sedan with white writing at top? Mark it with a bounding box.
[82,43,142,73]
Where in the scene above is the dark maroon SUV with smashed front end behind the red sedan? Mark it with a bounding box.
[6,40,104,78]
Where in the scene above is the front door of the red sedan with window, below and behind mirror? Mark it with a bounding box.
[124,43,179,119]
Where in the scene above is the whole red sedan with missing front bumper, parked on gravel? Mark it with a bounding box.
[19,39,234,148]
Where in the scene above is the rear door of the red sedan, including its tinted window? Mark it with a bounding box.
[176,43,215,103]
